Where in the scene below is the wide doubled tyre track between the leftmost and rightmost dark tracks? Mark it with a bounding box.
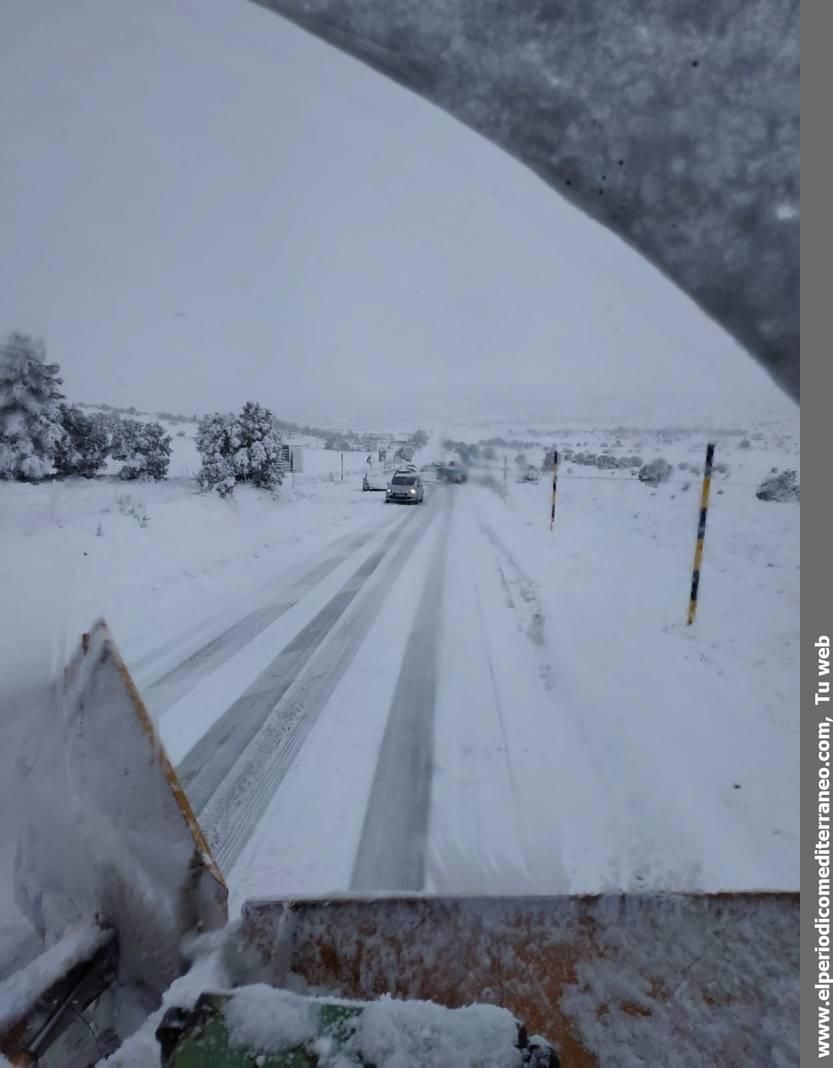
[199,501,436,873]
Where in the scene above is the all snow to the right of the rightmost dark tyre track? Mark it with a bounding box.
[431,425,800,891]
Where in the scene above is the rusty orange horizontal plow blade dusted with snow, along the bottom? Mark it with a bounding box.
[241,893,799,1068]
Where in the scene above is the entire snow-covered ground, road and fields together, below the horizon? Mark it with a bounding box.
[0,425,799,939]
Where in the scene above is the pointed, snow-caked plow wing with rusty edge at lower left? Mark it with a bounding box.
[7,623,227,1052]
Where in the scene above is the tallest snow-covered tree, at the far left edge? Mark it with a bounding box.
[0,331,64,482]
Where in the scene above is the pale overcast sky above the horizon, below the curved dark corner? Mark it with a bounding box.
[0,0,798,425]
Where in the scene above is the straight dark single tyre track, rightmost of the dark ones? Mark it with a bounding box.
[350,493,454,892]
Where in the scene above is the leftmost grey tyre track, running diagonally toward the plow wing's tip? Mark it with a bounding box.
[135,516,403,717]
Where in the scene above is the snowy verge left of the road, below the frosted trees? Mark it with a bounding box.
[0,437,378,685]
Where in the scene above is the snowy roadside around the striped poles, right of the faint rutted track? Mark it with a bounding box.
[461,418,800,892]
